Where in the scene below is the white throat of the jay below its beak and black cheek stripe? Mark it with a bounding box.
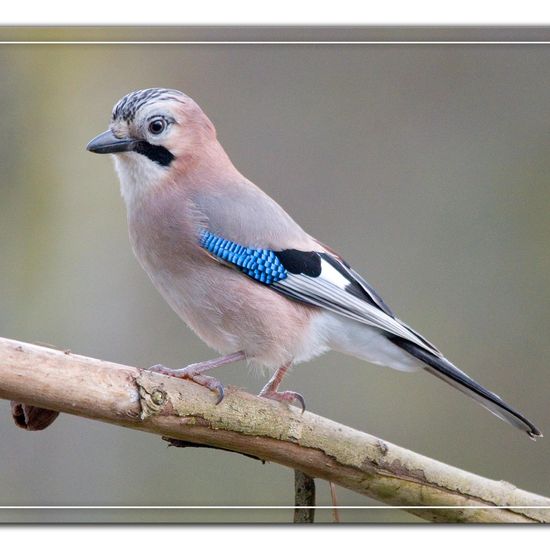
[113,152,168,208]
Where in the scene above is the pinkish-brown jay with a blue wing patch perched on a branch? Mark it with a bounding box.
[87,88,542,439]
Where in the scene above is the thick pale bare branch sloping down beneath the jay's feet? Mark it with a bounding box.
[0,338,550,523]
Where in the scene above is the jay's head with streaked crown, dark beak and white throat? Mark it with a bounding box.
[87,88,216,203]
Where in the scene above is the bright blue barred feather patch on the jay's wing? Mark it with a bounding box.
[200,229,288,285]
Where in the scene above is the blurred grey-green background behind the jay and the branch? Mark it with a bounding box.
[0,35,550,522]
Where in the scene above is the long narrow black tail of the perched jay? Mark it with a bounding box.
[388,336,542,440]
